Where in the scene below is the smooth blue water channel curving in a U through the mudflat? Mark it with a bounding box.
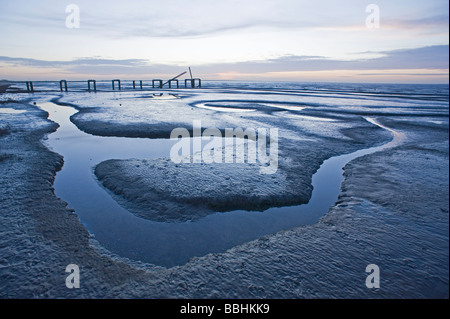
[39,102,402,267]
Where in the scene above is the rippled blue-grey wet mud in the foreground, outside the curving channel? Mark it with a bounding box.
[0,87,449,298]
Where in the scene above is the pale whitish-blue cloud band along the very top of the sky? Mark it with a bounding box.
[7,0,448,38]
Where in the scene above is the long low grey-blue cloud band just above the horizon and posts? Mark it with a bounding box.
[0,45,449,79]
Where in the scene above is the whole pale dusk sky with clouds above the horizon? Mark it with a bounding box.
[0,0,449,83]
